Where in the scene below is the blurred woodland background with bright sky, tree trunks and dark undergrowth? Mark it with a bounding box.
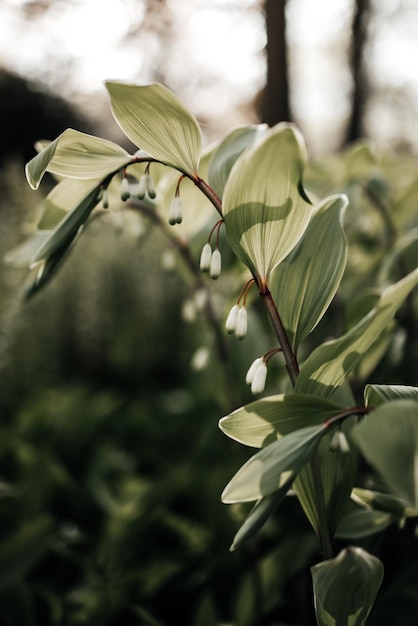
[0,0,418,626]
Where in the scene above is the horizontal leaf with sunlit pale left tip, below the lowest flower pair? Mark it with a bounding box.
[219,393,341,448]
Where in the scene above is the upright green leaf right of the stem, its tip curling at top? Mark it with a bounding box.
[271,195,348,347]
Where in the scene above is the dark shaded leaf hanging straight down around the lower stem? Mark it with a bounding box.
[293,418,358,536]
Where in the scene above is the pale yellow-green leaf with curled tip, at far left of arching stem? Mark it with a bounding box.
[26,128,133,189]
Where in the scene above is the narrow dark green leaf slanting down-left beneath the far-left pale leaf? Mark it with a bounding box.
[32,184,101,264]
